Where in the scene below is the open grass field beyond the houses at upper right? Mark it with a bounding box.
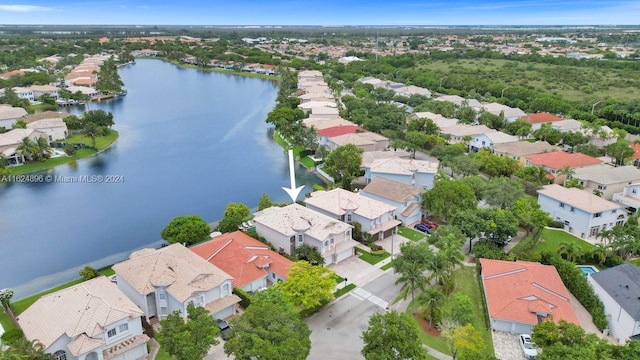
[421,59,640,100]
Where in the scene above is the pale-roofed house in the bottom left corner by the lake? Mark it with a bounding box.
[17,276,149,360]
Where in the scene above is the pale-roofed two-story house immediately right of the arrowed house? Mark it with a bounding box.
[305,188,401,241]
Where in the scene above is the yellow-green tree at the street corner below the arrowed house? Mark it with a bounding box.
[277,261,336,310]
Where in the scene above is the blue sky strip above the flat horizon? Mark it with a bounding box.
[0,0,640,26]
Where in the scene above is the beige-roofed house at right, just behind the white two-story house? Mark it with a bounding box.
[570,164,640,200]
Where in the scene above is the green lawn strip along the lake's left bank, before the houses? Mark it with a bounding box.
[9,130,118,175]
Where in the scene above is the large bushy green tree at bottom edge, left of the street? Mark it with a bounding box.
[224,286,312,360]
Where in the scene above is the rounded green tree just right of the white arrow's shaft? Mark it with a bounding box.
[324,144,364,190]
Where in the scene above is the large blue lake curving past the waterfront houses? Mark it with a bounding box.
[0,60,320,299]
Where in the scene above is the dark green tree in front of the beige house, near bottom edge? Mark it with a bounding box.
[156,303,220,360]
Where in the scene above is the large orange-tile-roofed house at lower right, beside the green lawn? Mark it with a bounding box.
[480,259,580,334]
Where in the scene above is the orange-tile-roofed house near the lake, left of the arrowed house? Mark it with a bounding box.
[190,231,292,292]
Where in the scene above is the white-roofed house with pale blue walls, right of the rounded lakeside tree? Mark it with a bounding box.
[364,158,440,190]
